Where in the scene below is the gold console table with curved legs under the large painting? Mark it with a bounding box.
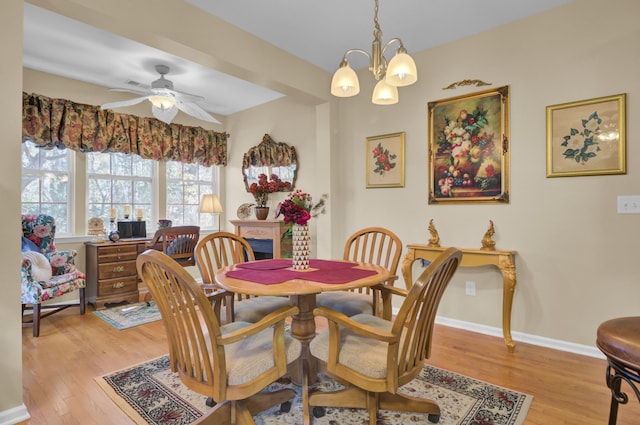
[402,245,517,353]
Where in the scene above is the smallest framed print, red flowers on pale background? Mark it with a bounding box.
[365,132,404,189]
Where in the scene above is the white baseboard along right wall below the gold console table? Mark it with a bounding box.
[436,316,605,359]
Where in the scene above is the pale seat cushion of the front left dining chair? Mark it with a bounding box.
[220,322,302,385]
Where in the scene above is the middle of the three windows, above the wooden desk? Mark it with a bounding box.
[86,153,156,225]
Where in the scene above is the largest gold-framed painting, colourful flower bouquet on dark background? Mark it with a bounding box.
[428,86,509,204]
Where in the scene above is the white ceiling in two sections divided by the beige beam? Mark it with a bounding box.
[23,0,573,116]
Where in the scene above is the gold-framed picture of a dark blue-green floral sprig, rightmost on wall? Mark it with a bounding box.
[547,93,627,177]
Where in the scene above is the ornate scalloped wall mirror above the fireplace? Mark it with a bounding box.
[242,134,298,192]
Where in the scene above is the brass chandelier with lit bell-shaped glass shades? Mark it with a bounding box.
[331,0,418,105]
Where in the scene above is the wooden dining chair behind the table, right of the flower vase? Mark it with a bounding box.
[316,227,402,319]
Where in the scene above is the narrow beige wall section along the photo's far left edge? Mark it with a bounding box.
[0,0,26,423]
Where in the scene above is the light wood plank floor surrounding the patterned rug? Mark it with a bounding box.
[22,306,640,425]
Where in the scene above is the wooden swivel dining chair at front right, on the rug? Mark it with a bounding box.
[303,248,462,425]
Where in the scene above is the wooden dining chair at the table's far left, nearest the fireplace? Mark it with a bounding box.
[195,232,290,323]
